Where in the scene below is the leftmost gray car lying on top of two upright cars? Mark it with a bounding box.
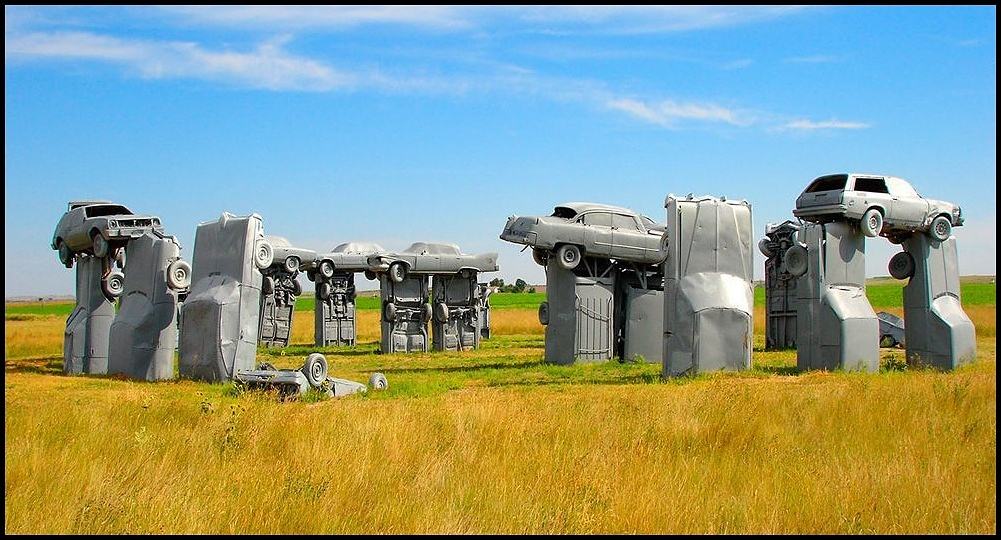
[52,200,164,267]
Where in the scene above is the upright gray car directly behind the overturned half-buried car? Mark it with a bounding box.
[179,213,274,381]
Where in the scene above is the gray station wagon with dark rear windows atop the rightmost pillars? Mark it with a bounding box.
[793,174,963,243]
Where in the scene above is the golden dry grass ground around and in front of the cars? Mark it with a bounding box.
[4,286,997,533]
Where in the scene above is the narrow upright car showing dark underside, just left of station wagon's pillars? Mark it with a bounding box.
[758,220,800,349]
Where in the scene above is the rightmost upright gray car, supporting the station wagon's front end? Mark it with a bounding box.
[891,233,977,370]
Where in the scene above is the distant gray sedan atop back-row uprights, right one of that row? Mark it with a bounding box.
[368,241,498,284]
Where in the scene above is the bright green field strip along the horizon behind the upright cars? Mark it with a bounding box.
[6,278,997,318]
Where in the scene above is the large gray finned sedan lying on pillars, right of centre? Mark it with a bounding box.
[501,202,667,269]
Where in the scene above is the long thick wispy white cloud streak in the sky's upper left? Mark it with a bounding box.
[4,32,356,91]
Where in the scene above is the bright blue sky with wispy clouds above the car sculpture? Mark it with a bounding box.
[4,6,997,297]
